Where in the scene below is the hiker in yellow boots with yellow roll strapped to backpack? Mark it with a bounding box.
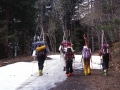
[36,44,48,76]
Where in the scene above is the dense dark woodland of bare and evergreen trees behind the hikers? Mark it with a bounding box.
[0,0,120,59]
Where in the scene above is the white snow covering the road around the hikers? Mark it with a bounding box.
[0,55,102,90]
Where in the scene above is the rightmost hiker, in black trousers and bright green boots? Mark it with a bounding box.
[99,43,110,76]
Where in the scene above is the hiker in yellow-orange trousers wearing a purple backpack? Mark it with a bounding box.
[82,46,91,75]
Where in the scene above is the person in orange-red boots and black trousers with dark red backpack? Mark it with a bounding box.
[65,48,75,77]
